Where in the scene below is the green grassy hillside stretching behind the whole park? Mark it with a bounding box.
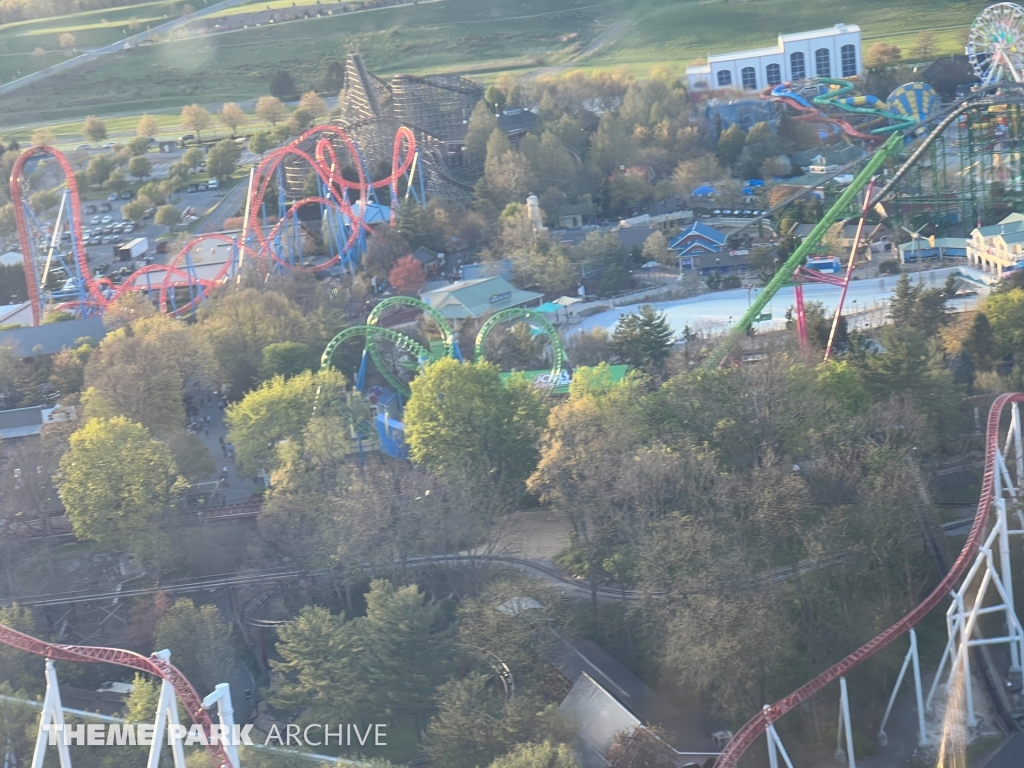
[0,0,985,125]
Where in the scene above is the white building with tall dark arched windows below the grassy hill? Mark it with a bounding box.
[686,24,862,92]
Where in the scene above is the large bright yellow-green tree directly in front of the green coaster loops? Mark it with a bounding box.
[406,358,545,500]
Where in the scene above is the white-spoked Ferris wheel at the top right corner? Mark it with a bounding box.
[967,3,1024,85]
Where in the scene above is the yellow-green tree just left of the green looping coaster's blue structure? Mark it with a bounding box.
[226,370,345,473]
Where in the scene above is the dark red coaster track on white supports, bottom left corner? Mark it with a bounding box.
[0,624,231,768]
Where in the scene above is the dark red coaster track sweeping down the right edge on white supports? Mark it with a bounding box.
[715,392,1024,768]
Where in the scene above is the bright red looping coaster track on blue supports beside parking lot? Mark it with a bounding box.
[10,125,416,326]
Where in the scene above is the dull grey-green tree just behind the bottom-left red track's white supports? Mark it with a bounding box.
[154,598,234,690]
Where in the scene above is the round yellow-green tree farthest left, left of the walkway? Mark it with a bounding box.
[57,416,179,554]
